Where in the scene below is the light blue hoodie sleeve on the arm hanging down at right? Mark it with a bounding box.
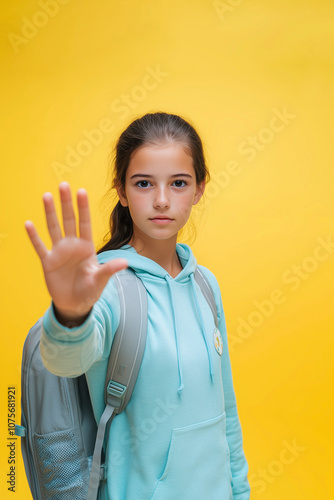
[200,266,250,500]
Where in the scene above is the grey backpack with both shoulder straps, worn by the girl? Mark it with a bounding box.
[15,268,218,500]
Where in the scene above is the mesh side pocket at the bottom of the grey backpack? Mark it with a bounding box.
[34,429,87,500]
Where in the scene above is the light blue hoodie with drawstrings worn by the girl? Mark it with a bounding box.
[41,244,250,500]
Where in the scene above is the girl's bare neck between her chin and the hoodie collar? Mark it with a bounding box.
[129,237,182,278]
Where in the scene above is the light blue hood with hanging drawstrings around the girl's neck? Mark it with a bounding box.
[97,243,213,394]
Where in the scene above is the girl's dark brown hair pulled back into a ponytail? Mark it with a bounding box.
[97,112,210,253]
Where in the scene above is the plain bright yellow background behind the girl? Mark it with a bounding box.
[0,0,334,500]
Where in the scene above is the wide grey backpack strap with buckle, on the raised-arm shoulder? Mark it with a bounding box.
[87,268,147,500]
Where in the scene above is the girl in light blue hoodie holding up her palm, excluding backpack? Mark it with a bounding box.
[25,113,250,500]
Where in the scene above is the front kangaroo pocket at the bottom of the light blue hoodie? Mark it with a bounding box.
[150,412,232,500]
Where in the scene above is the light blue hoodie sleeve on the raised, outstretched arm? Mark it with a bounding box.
[40,279,120,377]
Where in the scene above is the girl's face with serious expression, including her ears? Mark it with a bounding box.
[117,144,205,246]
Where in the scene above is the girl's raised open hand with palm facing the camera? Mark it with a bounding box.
[25,182,128,321]
